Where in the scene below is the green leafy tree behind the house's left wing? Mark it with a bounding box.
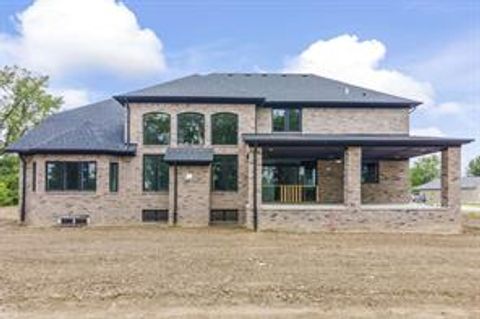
[0,66,62,206]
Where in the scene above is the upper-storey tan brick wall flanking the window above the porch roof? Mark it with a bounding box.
[257,107,409,134]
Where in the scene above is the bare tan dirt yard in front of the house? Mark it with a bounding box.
[0,211,480,319]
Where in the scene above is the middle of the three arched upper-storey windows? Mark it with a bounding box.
[177,113,205,144]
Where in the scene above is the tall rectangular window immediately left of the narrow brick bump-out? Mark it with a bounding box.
[143,155,169,192]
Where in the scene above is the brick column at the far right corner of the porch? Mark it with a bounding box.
[441,147,461,214]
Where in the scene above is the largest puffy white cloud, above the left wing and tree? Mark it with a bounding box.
[0,0,166,76]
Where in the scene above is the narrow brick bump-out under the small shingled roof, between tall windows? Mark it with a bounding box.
[177,165,210,226]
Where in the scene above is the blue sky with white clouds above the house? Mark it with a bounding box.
[0,0,480,171]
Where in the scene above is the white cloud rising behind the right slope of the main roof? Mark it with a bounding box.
[284,34,434,106]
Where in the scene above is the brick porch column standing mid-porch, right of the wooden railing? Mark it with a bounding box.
[343,146,362,209]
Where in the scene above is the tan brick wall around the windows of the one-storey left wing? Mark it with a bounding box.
[22,155,168,225]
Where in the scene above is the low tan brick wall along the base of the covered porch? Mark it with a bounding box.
[259,205,461,233]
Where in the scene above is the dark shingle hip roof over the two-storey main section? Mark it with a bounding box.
[116,73,420,107]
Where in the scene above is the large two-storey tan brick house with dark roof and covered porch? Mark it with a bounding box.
[8,73,471,231]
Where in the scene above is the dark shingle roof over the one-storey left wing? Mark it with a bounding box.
[7,99,135,155]
